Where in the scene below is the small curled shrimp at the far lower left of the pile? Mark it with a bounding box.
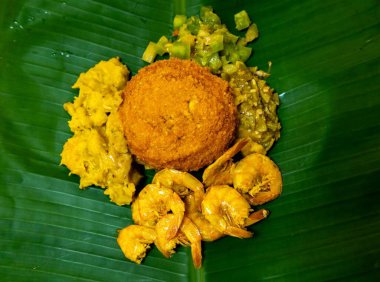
[117,225,156,264]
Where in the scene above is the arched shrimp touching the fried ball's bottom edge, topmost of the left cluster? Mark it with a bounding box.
[152,168,204,209]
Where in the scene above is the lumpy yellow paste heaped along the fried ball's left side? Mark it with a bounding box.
[61,58,141,205]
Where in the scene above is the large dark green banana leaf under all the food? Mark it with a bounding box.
[0,0,380,281]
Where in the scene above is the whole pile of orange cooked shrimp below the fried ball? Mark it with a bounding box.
[117,139,282,268]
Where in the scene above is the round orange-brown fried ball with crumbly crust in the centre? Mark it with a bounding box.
[120,59,237,171]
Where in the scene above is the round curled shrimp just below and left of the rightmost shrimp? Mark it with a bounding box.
[202,185,252,238]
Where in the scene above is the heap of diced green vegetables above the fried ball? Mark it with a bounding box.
[144,7,258,74]
